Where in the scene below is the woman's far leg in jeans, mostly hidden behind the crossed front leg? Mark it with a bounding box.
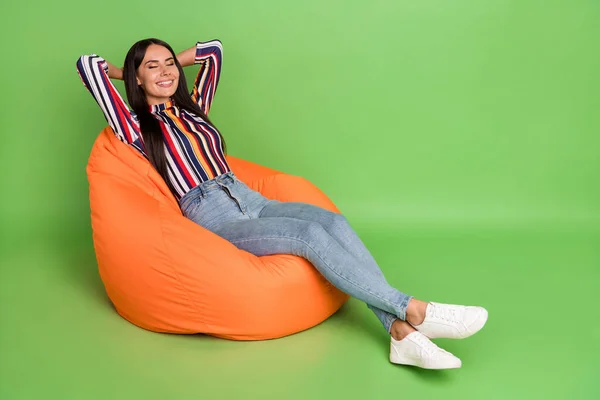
[260,202,412,333]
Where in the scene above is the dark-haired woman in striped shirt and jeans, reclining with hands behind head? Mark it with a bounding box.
[77,39,487,369]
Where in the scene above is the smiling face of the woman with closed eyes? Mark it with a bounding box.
[136,44,179,105]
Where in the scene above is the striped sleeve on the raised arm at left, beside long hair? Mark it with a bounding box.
[77,54,143,153]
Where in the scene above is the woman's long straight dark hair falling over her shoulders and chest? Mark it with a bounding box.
[123,38,226,195]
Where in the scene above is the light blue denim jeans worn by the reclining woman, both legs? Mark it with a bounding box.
[180,172,412,332]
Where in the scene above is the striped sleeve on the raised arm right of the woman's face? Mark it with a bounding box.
[192,40,223,115]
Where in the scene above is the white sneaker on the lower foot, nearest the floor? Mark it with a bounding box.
[390,332,462,369]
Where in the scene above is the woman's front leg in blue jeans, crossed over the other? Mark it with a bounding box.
[213,217,410,318]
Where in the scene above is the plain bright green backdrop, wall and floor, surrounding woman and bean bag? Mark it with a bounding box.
[0,0,600,399]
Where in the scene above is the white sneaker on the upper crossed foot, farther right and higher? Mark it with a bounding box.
[413,303,488,339]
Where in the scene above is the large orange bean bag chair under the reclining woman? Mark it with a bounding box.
[86,127,348,340]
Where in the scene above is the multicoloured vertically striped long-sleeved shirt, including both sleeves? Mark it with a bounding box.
[77,40,230,200]
